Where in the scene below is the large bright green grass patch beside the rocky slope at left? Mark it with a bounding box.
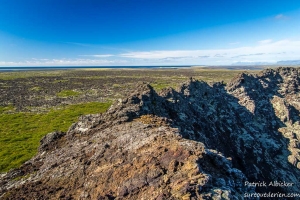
[0,102,111,172]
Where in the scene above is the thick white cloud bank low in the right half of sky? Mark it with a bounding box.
[119,39,300,64]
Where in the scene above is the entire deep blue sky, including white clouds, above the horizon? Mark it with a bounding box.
[0,0,300,66]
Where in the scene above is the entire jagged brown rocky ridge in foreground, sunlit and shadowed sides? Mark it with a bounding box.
[0,68,300,200]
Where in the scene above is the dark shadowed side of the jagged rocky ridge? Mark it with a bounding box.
[102,68,300,195]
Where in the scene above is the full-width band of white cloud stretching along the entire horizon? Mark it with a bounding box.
[0,39,300,66]
